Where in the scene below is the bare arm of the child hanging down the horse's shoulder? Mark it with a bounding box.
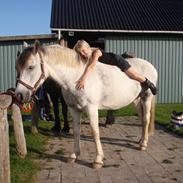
[76,49,102,90]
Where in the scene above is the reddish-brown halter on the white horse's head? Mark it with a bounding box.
[17,53,45,96]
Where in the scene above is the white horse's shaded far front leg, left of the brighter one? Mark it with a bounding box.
[69,108,81,162]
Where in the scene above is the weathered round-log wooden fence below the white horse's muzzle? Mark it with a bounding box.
[0,93,27,183]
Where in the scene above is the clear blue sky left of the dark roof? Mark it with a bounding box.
[0,0,52,36]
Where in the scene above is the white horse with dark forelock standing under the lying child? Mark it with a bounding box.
[15,41,157,168]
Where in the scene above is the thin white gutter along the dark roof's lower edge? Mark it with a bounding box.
[51,28,183,34]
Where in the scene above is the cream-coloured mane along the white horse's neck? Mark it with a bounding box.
[44,45,84,67]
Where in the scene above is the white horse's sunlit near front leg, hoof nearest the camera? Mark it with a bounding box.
[87,105,104,169]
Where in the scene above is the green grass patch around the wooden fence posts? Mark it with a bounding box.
[10,118,53,183]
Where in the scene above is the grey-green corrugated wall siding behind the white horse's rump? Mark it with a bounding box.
[105,35,183,103]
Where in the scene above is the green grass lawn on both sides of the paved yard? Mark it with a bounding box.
[10,104,183,183]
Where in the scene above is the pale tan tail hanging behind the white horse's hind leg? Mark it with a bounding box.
[148,96,155,135]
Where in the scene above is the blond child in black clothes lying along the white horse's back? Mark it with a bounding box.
[74,40,157,95]
